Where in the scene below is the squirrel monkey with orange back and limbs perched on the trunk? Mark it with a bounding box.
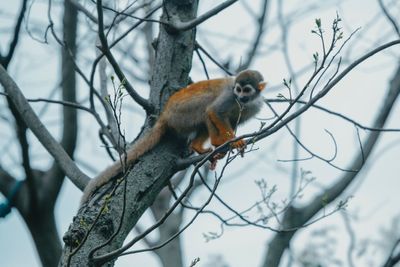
[81,70,266,203]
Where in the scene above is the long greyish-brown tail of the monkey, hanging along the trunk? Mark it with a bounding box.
[81,117,167,206]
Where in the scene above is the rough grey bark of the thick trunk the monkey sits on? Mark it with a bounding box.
[60,0,197,266]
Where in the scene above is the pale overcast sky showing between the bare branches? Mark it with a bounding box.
[0,0,400,267]
